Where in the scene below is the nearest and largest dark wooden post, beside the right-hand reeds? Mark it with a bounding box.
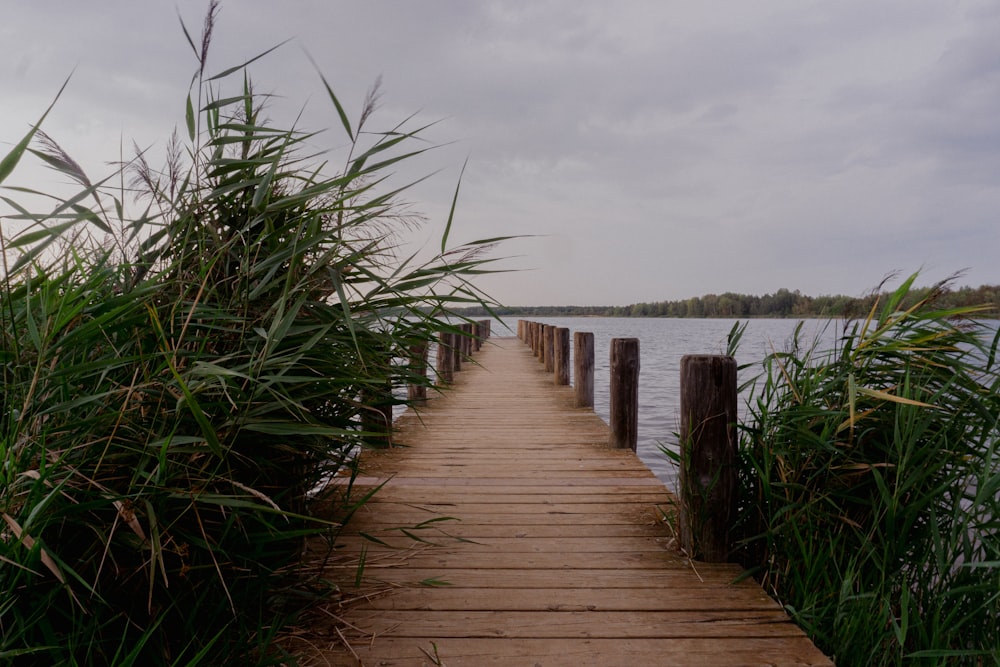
[680,355,737,563]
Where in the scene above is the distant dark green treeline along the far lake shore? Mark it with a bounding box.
[462,285,1000,318]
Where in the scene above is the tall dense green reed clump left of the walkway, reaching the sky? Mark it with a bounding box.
[0,2,497,665]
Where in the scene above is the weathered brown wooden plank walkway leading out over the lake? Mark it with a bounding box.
[301,338,832,667]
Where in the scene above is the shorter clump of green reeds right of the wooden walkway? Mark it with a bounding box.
[737,276,1000,666]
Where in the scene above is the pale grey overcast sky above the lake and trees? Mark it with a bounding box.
[0,0,1000,306]
